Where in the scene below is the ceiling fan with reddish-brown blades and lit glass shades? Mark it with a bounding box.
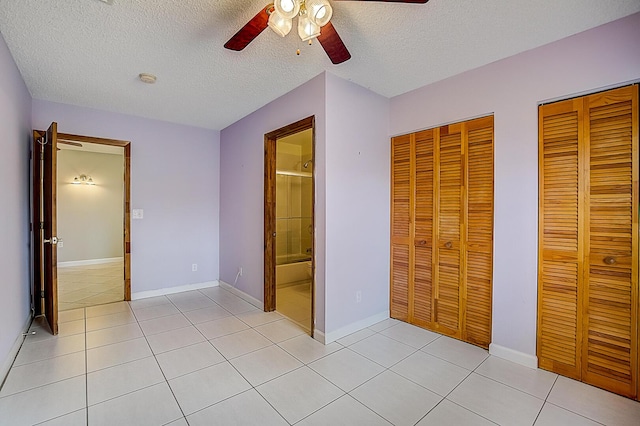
[224,0,429,64]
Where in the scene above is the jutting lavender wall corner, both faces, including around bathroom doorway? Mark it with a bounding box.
[220,73,389,341]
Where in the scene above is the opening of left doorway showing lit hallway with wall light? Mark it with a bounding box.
[57,140,125,311]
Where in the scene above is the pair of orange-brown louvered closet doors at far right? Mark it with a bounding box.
[538,86,639,397]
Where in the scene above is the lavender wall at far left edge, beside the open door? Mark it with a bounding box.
[0,36,31,381]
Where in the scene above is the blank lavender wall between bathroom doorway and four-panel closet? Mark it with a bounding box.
[325,73,390,341]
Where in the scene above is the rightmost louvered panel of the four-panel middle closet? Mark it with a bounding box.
[463,117,493,347]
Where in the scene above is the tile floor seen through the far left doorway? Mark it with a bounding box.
[58,261,124,311]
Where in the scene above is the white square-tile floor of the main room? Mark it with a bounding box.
[0,287,640,426]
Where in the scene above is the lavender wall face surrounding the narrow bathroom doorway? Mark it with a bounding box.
[220,74,326,330]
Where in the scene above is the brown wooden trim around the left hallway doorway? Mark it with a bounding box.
[34,130,131,300]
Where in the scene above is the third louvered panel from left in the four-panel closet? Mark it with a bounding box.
[434,124,462,337]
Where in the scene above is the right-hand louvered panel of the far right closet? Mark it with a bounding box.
[582,87,638,397]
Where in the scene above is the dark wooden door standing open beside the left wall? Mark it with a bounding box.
[32,123,58,334]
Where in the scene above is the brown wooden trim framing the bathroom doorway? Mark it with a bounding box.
[264,116,316,336]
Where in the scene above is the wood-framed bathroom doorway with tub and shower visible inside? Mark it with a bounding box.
[265,117,315,335]
